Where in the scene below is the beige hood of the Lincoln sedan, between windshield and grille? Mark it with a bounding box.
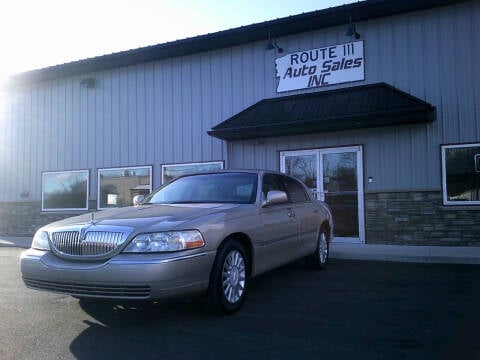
[47,204,241,231]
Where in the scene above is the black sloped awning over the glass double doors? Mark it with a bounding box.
[208,83,435,141]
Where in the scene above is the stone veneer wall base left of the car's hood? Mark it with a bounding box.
[0,200,97,236]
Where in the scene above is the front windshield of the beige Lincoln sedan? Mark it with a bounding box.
[142,172,257,204]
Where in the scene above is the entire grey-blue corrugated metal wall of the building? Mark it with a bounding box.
[0,1,480,201]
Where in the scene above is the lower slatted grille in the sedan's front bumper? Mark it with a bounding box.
[23,278,150,299]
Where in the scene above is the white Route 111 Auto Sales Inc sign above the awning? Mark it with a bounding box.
[275,41,365,92]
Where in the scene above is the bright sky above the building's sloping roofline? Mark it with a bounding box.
[0,0,354,85]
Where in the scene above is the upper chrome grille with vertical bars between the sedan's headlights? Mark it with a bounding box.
[51,231,126,257]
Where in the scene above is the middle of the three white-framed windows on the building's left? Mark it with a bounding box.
[97,166,152,210]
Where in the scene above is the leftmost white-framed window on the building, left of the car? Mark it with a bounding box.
[42,170,89,211]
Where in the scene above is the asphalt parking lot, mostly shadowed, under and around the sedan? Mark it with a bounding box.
[0,248,480,360]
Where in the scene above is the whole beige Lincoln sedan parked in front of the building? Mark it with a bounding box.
[21,170,333,312]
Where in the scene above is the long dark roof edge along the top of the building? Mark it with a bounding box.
[10,0,465,85]
